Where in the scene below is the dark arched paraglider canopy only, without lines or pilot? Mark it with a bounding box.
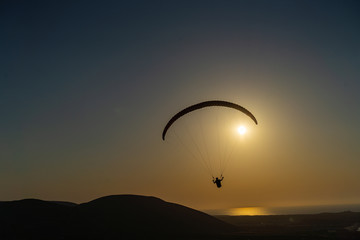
[162,100,257,140]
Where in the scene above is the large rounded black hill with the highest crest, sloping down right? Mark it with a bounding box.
[77,195,236,235]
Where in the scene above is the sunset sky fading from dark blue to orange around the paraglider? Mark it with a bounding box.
[0,0,360,209]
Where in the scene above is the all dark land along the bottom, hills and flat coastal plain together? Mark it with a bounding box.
[0,195,360,240]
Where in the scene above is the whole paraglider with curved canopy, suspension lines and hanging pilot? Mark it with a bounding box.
[162,100,258,188]
